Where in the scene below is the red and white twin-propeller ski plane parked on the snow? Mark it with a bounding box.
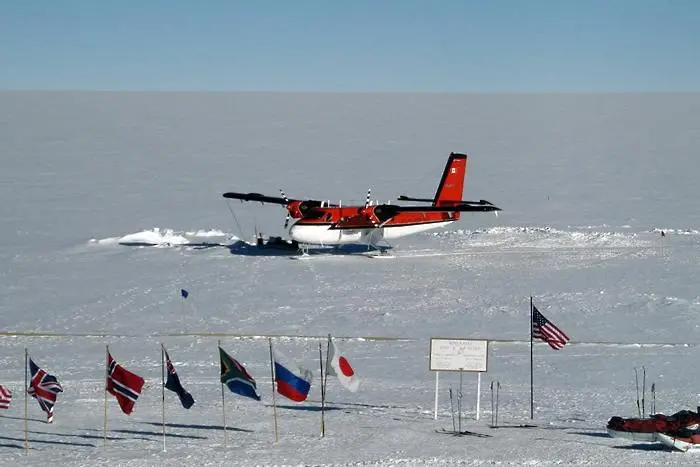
[223,153,500,252]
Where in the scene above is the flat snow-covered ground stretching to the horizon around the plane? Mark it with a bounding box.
[0,93,700,466]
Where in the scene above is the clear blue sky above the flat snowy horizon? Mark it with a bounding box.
[0,0,700,92]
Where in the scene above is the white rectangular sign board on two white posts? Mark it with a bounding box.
[430,337,489,420]
